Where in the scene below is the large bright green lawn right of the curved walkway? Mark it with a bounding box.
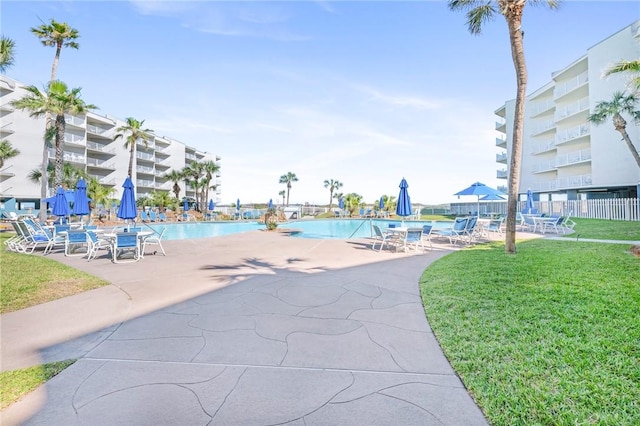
[420,240,640,425]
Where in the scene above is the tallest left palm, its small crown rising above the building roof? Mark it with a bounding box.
[31,19,80,222]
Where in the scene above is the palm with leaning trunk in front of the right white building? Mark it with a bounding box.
[589,92,640,167]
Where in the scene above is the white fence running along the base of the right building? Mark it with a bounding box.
[451,198,640,221]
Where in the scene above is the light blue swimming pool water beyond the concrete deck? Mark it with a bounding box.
[149,219,451,240]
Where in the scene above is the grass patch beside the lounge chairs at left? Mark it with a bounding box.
[0,233,109,314]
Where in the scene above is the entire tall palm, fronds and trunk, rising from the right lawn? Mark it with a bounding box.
[448,0,559,254]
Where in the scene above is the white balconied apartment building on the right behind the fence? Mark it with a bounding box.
[495,21,640,201]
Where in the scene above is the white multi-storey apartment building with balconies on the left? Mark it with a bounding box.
[0,76,222,212]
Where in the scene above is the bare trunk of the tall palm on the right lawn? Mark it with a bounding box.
[505,3,527,254]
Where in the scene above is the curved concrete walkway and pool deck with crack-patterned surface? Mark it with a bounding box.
[0,232,487,426]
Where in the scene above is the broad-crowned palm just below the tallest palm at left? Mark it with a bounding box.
[11,80,97,190]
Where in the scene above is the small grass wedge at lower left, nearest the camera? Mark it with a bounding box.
[0,359,76,410]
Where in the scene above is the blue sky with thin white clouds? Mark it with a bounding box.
[1,0,640,204]
